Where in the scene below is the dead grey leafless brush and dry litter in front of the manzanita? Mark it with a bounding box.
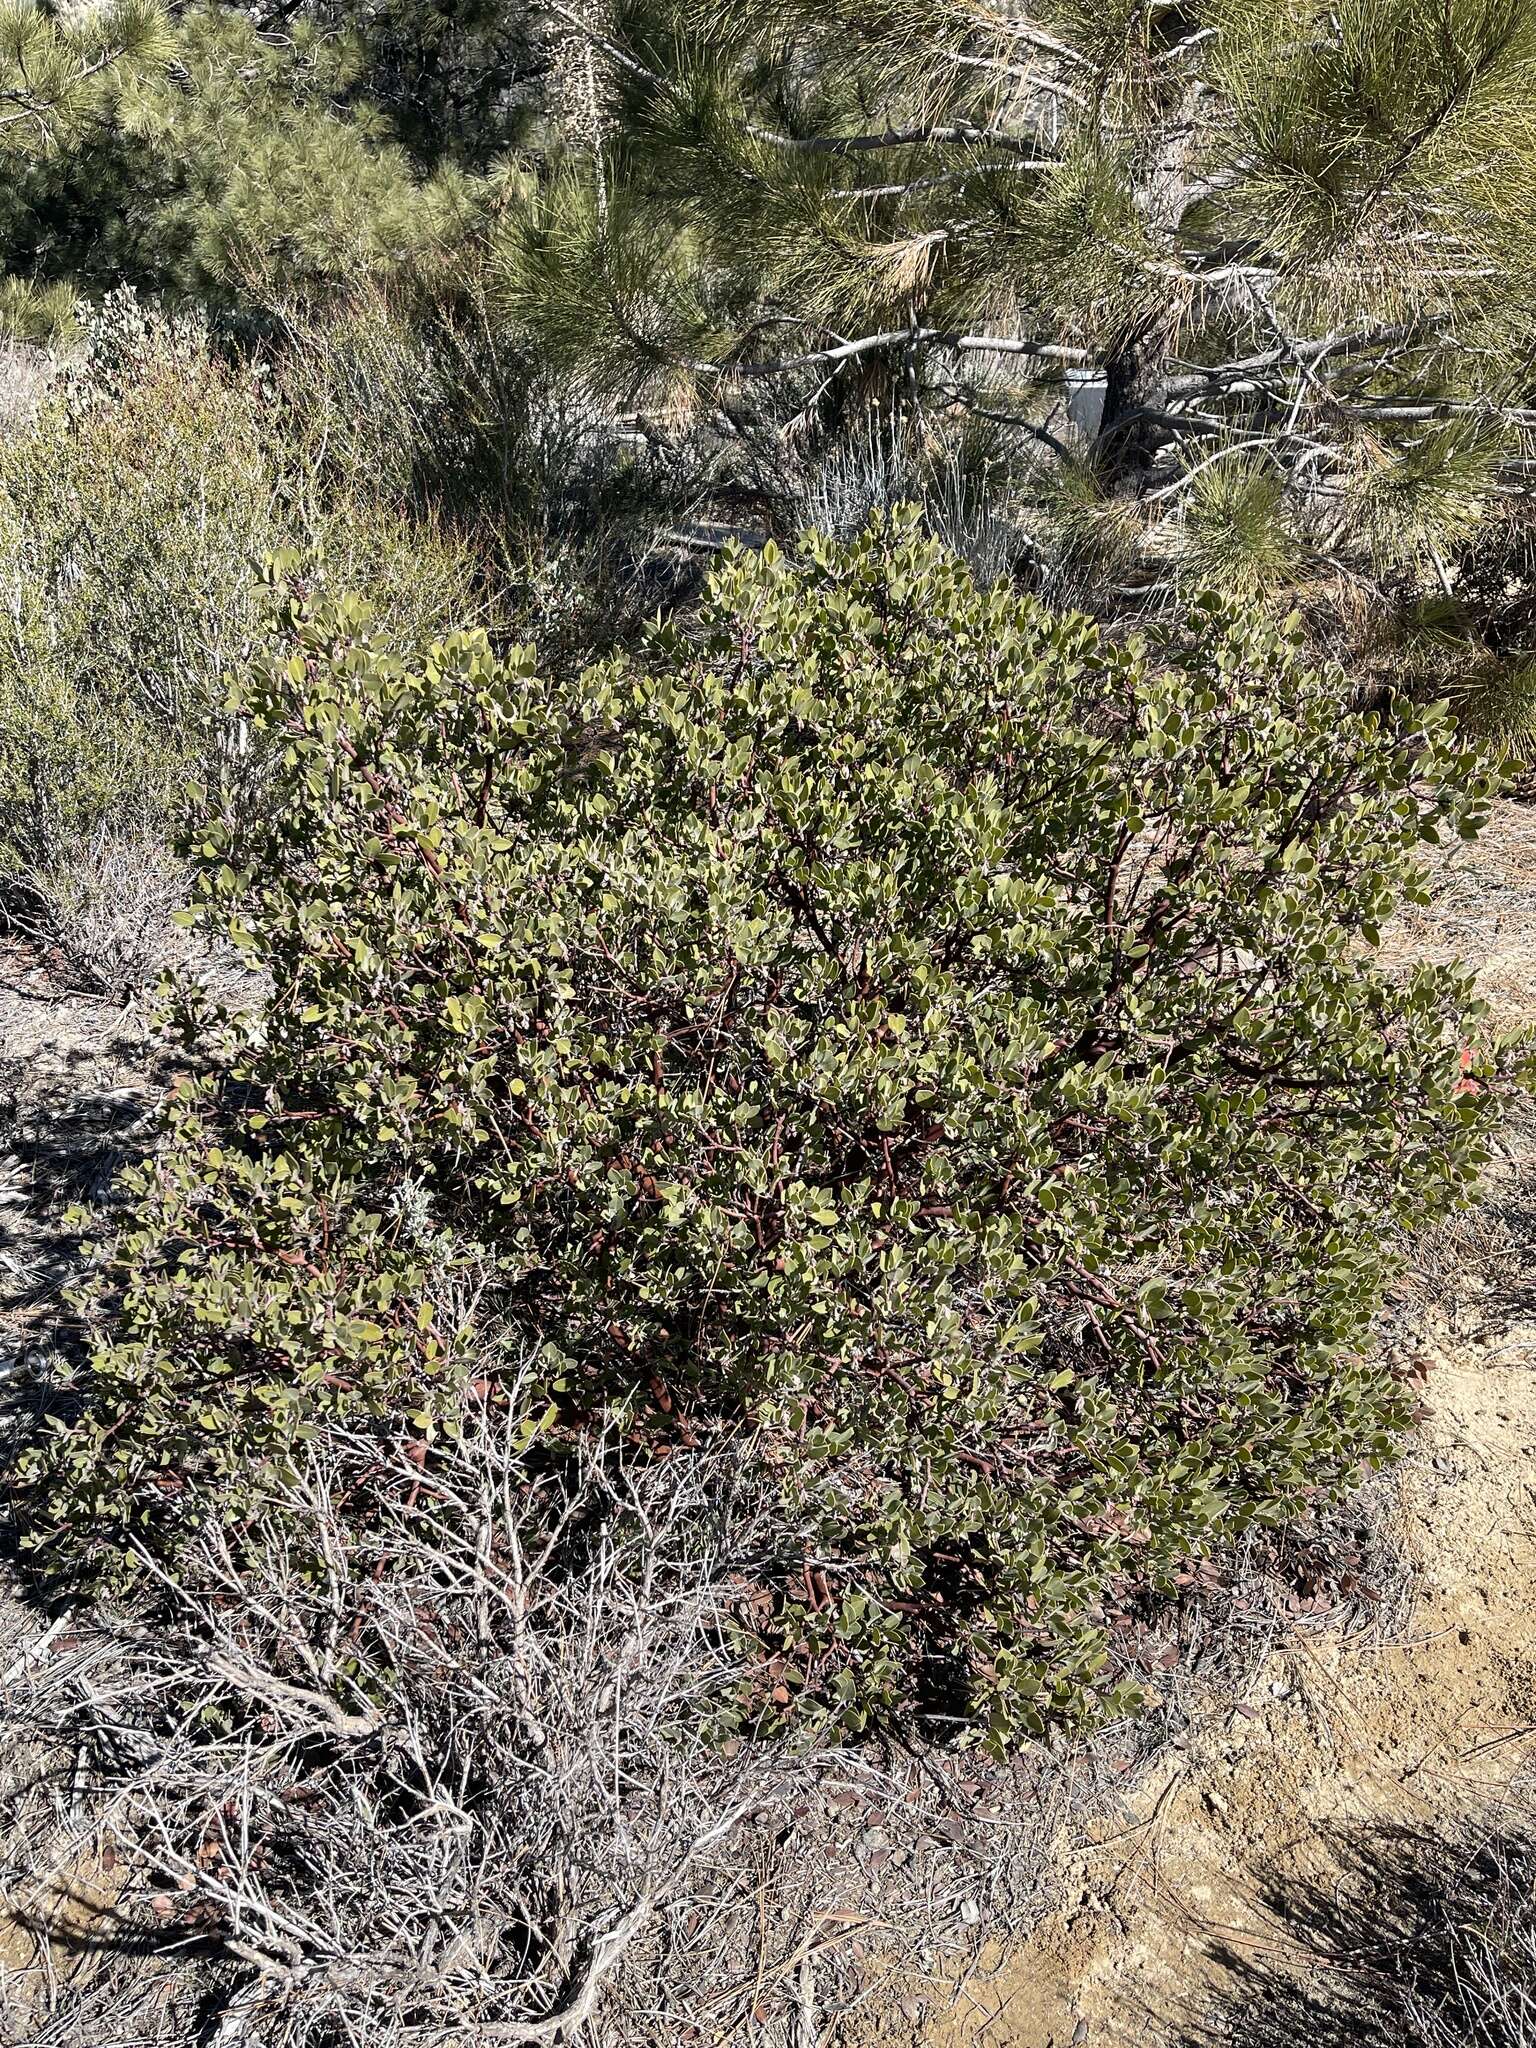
[4,1407,1077,2048]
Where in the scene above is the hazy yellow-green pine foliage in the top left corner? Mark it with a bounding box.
[0,0,493,326]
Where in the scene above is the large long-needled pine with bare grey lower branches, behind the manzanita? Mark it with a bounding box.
[506,0,1536,684]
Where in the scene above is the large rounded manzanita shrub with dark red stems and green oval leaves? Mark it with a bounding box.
[35,516,1511,1743]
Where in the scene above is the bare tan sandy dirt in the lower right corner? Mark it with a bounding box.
[926,1329,1536,2048]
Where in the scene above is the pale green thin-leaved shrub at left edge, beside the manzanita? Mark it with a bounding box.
[0,291,475,985]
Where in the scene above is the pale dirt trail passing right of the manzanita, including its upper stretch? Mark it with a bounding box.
[924,805,1536,2048]
